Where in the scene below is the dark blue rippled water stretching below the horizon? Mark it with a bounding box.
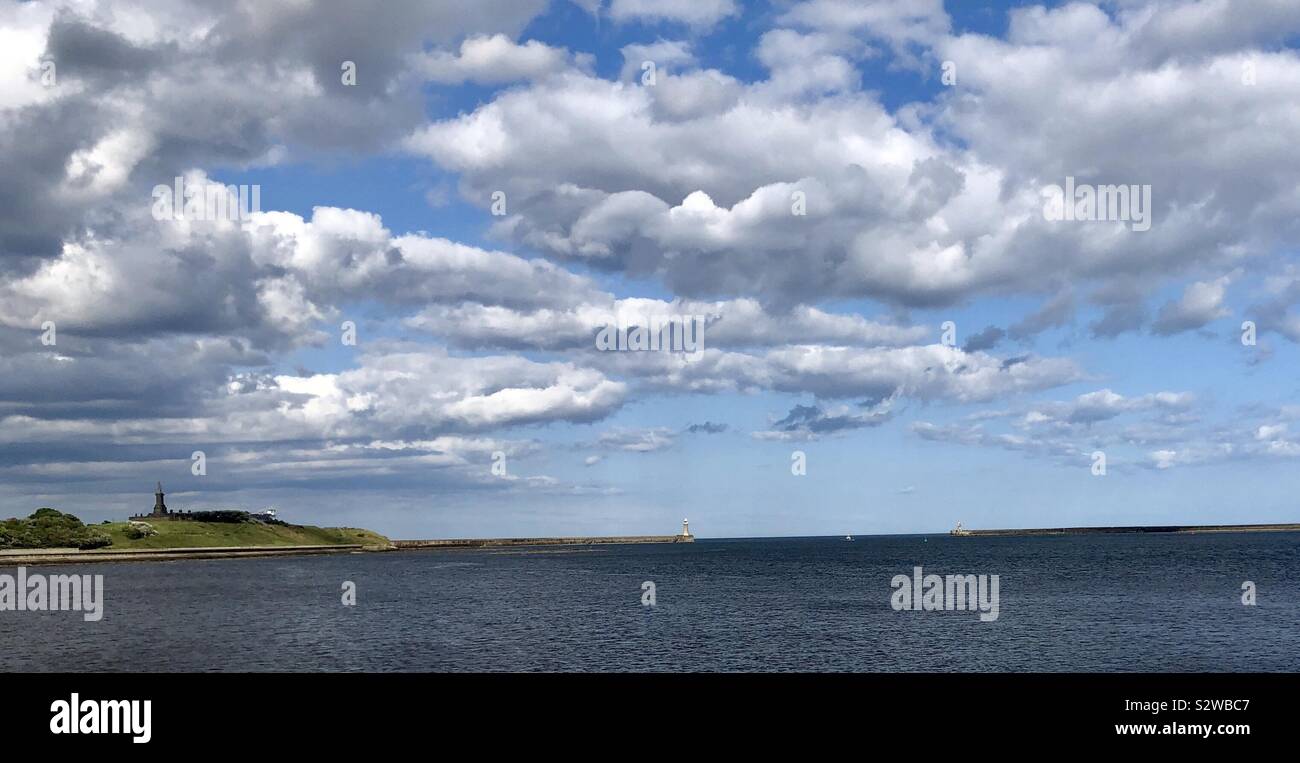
[0,533,1300,672]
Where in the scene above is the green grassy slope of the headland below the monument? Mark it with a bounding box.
[100,520,389,551]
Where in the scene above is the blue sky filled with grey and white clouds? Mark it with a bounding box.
[0,0,1300,538]
